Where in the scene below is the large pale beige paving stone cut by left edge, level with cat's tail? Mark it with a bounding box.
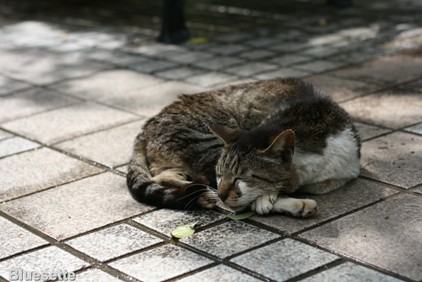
[0,148,101,202]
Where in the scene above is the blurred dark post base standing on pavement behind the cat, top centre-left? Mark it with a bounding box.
[157,0,190,44]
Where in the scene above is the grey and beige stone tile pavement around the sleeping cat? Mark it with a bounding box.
[0,0,422,281]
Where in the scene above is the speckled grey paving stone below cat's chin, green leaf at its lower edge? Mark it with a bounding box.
[133,209,225,237]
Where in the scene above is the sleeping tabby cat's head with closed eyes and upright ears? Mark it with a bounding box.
[209,125,296,211]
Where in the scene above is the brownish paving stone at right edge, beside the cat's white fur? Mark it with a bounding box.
[361,132,422,188]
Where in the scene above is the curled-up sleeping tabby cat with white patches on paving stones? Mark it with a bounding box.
[127,78,360,217]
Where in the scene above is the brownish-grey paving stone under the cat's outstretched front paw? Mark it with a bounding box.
[251,179,397,234]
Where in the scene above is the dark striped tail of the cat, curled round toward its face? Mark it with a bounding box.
[126,133,212,209]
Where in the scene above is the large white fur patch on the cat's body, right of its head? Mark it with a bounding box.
[293,128,360,185]
